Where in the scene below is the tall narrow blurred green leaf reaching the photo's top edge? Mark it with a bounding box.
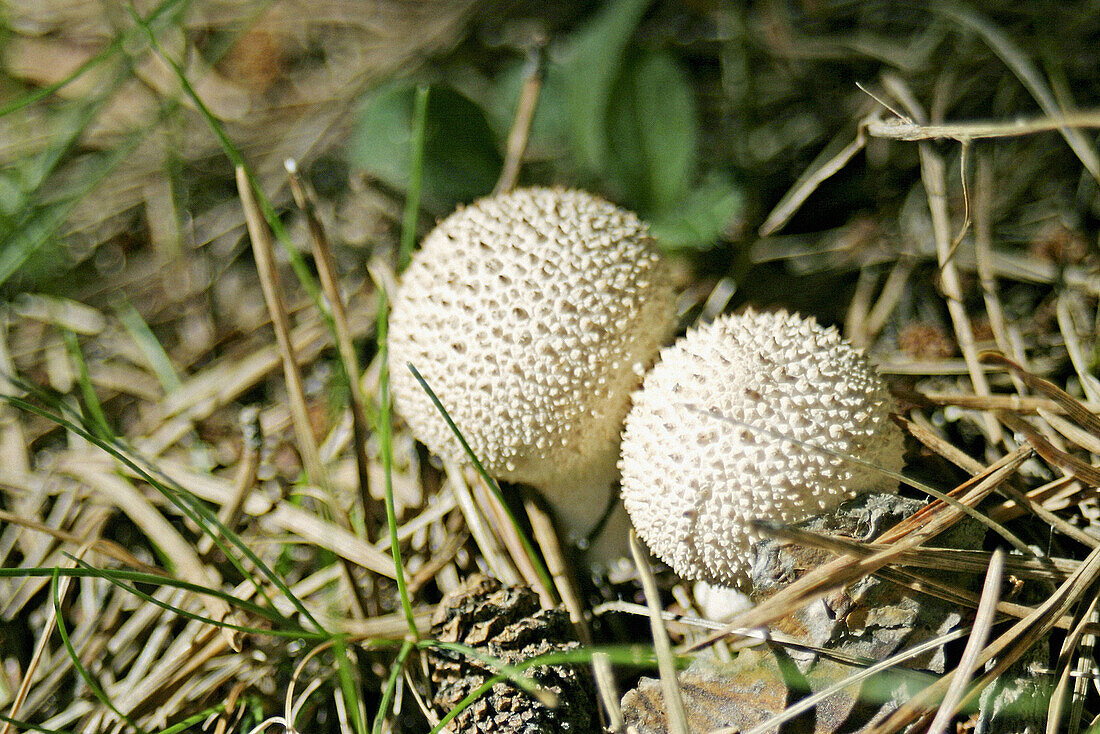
[563,0,650,175]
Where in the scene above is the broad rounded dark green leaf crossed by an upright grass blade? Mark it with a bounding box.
[350,84,502,215]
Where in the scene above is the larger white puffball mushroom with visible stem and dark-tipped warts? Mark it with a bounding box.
[389,188,674,550]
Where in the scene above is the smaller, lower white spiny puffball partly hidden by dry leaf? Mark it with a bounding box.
[620,311,904,590]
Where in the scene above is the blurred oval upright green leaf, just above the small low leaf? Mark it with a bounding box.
[607,53,697,213]
